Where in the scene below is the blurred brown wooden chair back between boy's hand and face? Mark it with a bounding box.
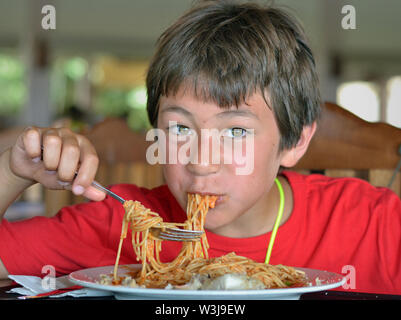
[45,118,163,216]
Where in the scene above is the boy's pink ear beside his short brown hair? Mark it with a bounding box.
[280,121,316,168]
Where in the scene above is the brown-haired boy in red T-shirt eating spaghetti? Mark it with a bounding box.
[0,1,401,294]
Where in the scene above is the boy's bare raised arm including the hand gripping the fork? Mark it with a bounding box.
[0,127,105,278]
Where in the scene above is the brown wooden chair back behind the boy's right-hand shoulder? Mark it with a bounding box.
[294,103,401,197]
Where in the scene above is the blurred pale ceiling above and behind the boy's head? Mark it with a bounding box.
[0,0,401,59]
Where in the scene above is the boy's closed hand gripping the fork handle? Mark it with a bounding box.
[10,127,105,201]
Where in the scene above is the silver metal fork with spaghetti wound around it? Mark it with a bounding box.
[92,181,204,241]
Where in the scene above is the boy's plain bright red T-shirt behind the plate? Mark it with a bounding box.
[0,171,401,294]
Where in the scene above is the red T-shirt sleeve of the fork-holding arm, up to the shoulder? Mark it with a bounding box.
[0,184,180,276]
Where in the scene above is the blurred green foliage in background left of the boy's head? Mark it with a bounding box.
[0,53,150,131]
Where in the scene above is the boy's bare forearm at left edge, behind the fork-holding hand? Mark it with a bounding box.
[0,149,33,221]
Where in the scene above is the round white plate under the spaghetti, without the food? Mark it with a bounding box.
[69,265,345,300]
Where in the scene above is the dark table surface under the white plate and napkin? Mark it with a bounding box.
[0,280,401,300]
